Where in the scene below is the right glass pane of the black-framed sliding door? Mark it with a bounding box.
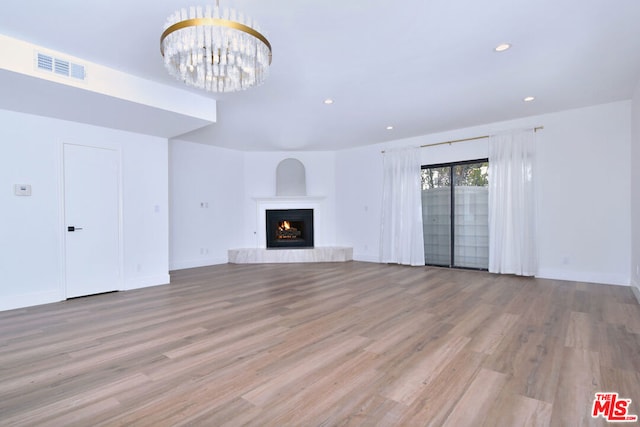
[453,163,489,269]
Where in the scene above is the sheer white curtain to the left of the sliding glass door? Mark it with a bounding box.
[380,148,424,266]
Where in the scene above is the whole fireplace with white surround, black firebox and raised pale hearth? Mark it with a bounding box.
[228,196,353,264]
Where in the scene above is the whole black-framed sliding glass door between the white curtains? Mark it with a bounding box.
[422,159,489,270]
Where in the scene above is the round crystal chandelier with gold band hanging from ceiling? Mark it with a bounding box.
[160,1,271,92]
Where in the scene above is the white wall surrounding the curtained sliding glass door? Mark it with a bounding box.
[336,101,631,284]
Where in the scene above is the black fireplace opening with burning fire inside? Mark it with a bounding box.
[265,209,313,248]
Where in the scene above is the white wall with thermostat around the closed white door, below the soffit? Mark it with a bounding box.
[0,110,169,310]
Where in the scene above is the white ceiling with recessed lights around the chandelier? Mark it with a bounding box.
[0,0,640,150]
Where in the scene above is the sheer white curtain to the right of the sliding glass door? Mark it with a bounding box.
[489,130,537,276]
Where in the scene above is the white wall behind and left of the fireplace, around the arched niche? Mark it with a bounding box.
[169,148,336,269]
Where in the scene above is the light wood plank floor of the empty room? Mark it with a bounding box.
[0,262,640,426]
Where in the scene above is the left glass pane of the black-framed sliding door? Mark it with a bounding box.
[422,166,451,267]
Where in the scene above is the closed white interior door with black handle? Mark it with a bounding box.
[64,144,121,298]
